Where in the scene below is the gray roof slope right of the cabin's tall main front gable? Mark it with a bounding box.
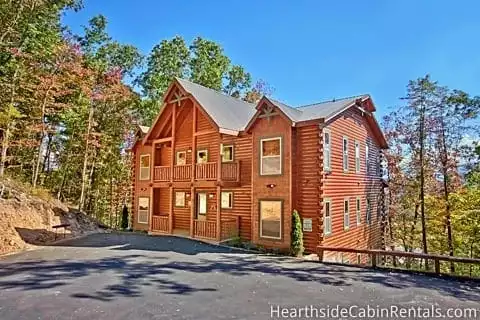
[176,78,257,131]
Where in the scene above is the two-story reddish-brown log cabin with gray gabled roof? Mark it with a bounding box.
[132,78,387,261]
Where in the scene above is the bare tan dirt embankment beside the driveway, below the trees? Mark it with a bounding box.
[0,180,104,255]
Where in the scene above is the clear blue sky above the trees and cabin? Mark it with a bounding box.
[63,0,480,116]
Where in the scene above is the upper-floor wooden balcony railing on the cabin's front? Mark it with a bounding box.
[153,161,240,182]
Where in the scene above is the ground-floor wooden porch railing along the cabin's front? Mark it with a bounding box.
[150,216,240,242]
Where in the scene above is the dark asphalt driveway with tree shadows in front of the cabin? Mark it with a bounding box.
[0,234,480,320]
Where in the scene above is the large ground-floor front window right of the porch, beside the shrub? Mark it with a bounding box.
[260,200,282,239]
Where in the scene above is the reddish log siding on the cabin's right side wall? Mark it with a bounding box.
[321,109,382,261]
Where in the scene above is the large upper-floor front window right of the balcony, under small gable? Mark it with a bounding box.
[260,137,282,176]
